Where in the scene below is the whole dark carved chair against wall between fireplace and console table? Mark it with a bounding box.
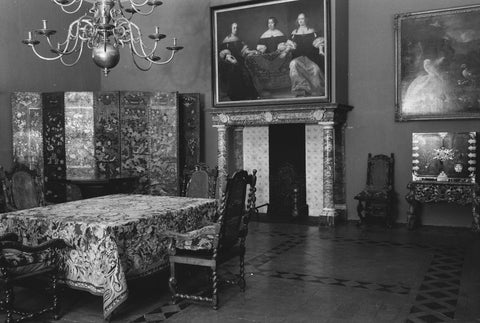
[354,153,394,227]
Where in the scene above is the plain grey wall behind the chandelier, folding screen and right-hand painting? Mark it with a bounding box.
[0,0,480,226]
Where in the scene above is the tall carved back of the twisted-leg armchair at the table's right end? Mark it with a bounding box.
[218,170,257,249]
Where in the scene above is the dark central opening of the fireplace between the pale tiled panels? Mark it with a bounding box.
[268,124,306,218]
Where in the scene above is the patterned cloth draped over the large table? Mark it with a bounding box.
[0,194,217,318]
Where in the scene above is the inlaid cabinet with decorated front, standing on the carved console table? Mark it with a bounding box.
[412,132,477,182]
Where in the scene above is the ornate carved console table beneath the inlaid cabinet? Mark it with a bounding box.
[405,181,480,232]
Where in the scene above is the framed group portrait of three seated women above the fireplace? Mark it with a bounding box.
[211,0,329,107]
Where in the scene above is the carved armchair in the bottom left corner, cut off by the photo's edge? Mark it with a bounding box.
[0,233,66,323]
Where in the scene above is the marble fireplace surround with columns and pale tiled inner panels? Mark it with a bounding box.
[209,103,352,226]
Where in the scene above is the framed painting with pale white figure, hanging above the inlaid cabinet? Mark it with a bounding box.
[395,6,480,121]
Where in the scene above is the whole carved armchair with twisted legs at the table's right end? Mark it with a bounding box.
[167,170,256,309]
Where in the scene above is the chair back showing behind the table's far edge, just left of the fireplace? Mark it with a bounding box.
[182,163,218,198]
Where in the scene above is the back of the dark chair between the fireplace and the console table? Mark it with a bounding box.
[367,153,394,191]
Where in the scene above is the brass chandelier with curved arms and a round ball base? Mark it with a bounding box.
[22,0,183,76]
